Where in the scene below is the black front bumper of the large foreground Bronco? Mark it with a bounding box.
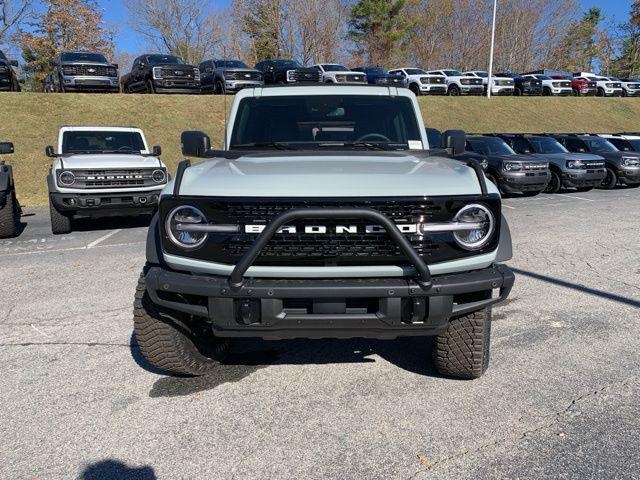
[145,265,515,340]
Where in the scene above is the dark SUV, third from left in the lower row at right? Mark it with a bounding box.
[551,134,640,190]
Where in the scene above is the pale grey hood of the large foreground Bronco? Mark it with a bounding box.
[167,151,480,198]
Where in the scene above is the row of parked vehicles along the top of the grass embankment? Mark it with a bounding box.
[0,52,640,97]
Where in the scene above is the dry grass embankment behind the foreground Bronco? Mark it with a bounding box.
[0,93,640,205]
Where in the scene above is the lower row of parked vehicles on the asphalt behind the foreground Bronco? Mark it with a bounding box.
[0,126,640,238]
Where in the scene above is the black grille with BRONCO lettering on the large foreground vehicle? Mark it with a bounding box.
[161,197,499,266]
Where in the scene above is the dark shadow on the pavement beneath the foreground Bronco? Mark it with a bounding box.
[136,336,438,398]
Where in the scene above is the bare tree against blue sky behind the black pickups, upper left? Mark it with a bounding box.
[129,0,222,64]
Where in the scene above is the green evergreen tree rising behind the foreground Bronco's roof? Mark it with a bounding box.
[348,0,411,65]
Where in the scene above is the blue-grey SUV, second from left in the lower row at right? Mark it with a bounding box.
[498,134,607,193]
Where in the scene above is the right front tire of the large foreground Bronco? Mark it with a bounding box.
[433,307,491,378]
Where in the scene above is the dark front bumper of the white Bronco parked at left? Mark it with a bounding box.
[50,189,162,214]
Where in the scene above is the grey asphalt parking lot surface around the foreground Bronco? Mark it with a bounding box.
[0,188,640,480]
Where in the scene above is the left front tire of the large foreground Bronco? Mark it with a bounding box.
[133,273,231,375]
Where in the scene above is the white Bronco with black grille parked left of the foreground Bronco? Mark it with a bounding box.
[46,126,167,234]
